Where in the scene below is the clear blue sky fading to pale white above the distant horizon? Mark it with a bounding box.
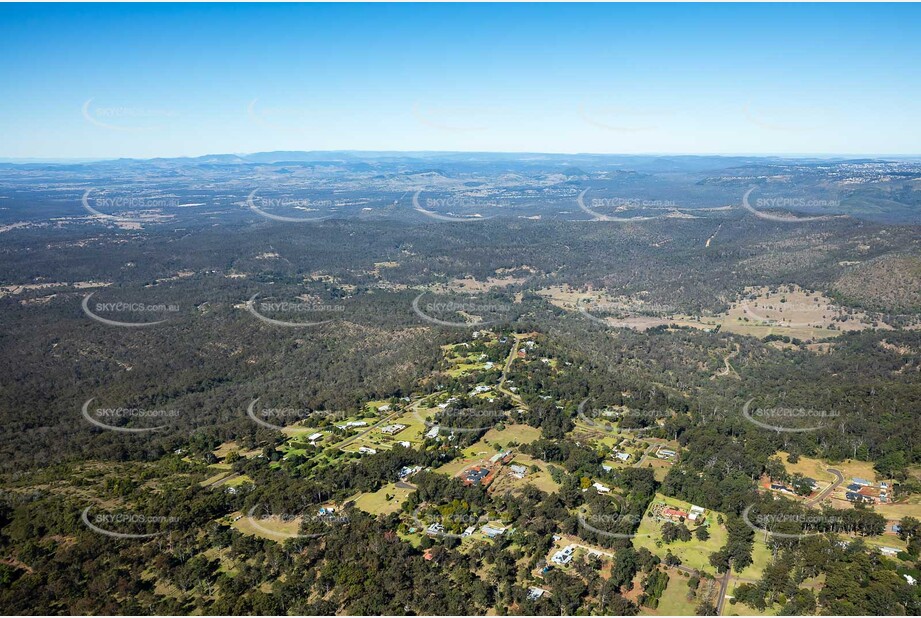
[0,4,921,158]
